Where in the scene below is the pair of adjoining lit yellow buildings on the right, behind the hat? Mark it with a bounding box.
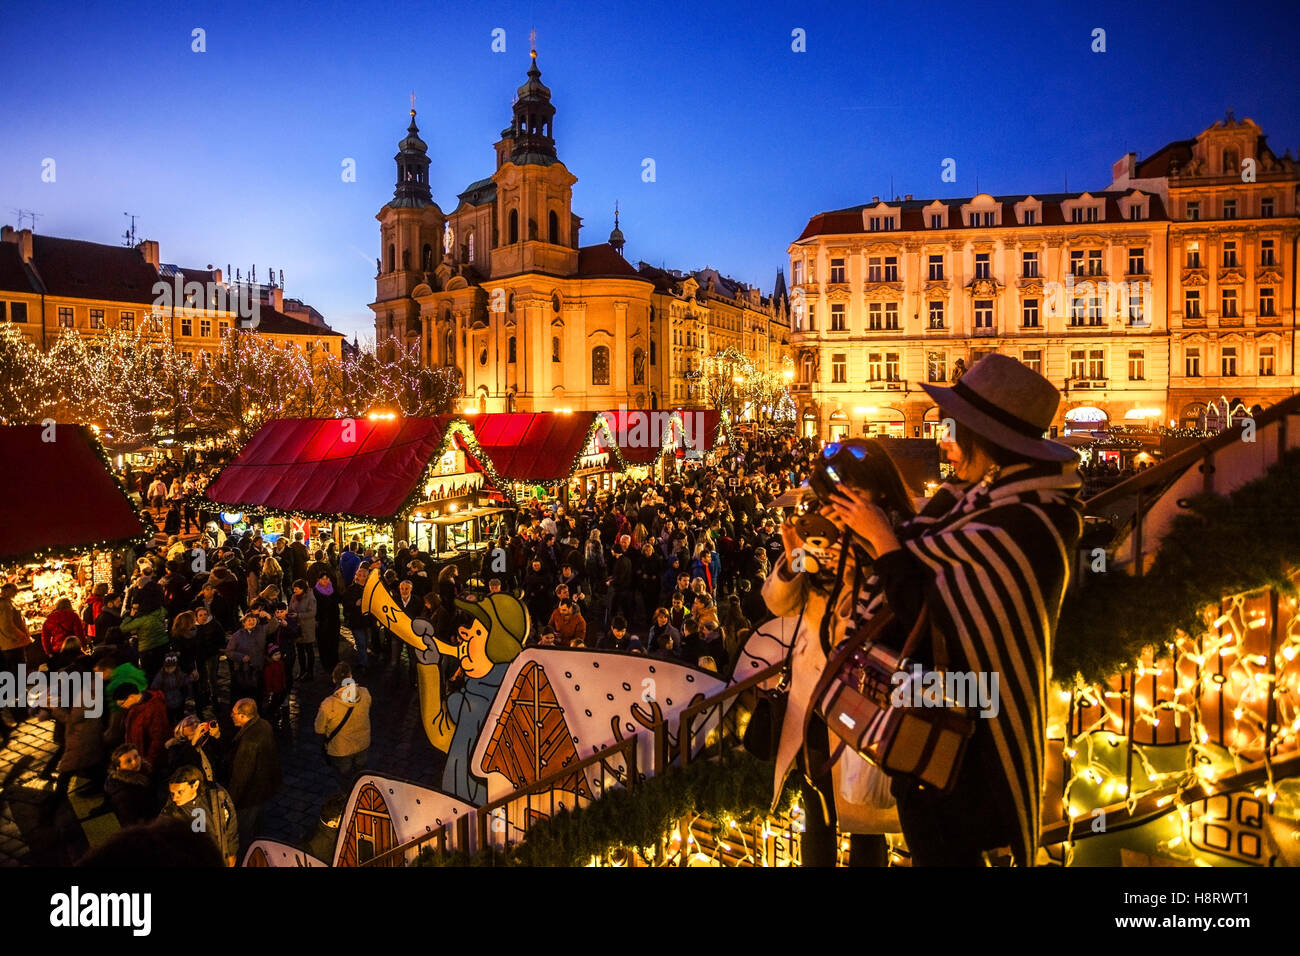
[788,120,1300,438]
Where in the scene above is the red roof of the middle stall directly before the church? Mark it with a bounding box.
[468,411,616,481]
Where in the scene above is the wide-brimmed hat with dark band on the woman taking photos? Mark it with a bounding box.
[920,352,1076,462]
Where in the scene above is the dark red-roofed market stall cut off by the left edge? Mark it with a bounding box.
[0,424,153,650]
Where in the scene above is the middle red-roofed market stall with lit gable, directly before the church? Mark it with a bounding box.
[472,411,625,505]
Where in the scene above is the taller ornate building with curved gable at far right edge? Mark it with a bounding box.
[1114,111,1300,427]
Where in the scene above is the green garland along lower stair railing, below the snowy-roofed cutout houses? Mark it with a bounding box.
[416,750,798,866]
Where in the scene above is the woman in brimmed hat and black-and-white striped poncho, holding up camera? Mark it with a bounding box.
[836,354,1083,866]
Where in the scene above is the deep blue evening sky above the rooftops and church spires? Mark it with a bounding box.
[0,0,1300,337]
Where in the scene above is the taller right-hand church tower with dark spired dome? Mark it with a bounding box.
[491,49,581,277]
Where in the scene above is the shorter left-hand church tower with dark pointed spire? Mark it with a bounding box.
[371,105,446,354]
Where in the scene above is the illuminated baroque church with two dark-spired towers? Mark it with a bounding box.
[371,49,664,412]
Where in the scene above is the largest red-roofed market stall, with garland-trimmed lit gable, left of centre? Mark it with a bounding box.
[204,415,507,559]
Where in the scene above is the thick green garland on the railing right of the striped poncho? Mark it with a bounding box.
[1052,450,1300,684]
